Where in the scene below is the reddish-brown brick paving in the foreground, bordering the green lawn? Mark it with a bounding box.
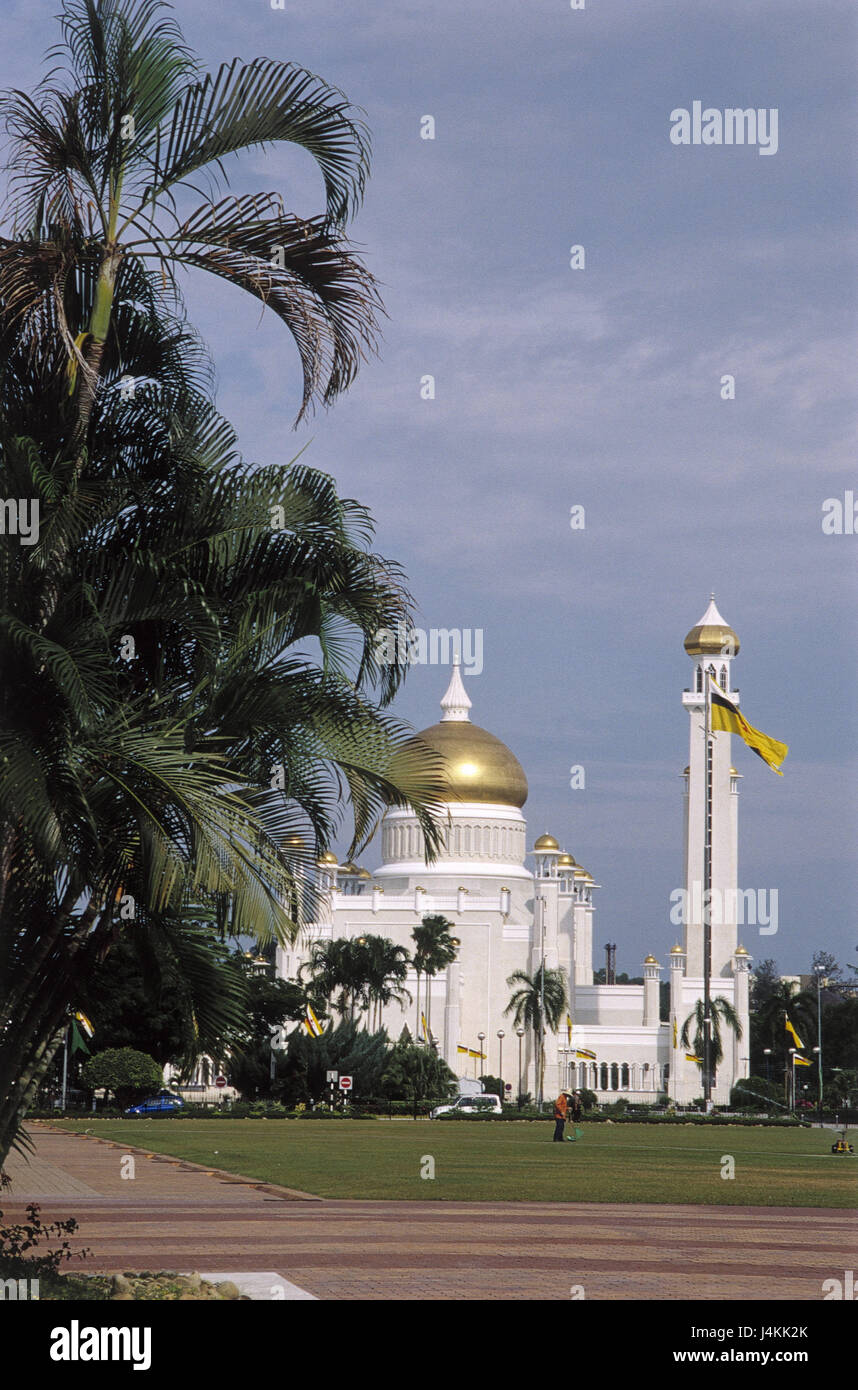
[0,1129,858,1301]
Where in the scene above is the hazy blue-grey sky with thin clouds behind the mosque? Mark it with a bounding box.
[0,0,858,974]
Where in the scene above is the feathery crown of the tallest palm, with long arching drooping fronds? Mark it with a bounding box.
[0,0,378,450]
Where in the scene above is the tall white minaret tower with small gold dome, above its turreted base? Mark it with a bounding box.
[683,595,738,992]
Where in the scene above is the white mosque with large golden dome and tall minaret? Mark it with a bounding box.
[277,599,751,1105]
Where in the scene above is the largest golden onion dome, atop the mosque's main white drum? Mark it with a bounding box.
[408,720,528,811]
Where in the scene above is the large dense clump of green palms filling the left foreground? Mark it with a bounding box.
[0,0,450,1162]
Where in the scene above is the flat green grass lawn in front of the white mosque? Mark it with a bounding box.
[55,1118,858,1207]
